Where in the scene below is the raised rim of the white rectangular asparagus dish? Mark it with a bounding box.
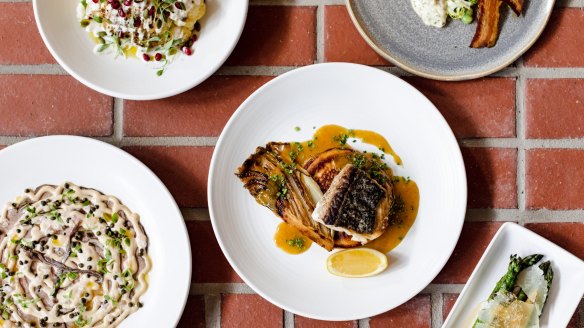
[442,222,584,328]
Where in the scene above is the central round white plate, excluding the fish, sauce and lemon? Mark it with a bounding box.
[208,63,466,320]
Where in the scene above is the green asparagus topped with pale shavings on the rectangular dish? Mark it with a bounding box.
[473,254,554,328]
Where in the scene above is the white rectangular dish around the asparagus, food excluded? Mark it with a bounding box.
[442,223,584,328]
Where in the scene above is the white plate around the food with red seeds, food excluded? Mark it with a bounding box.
[33,0,248,100]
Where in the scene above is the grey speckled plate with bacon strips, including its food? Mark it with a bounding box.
[346,0,555,80]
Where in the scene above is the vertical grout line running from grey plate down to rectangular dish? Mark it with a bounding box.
[515,58,526,220]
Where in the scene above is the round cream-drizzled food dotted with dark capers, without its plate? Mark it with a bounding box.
[0,183,151,327]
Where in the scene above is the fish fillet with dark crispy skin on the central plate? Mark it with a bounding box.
[312,164,391,244]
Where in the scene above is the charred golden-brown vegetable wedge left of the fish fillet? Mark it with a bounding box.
[236,144,334,251]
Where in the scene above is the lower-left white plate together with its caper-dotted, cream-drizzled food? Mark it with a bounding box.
[0,136,191,328]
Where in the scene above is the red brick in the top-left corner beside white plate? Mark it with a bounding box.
[0,3,55,65]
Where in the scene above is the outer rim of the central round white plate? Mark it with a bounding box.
[207,62,468,321]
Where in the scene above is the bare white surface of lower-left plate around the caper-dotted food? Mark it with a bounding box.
[0,136,191,328]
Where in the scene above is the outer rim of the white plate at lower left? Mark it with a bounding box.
[0,134,193,326]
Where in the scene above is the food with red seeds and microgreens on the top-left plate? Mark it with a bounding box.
[77,0,206,75]
